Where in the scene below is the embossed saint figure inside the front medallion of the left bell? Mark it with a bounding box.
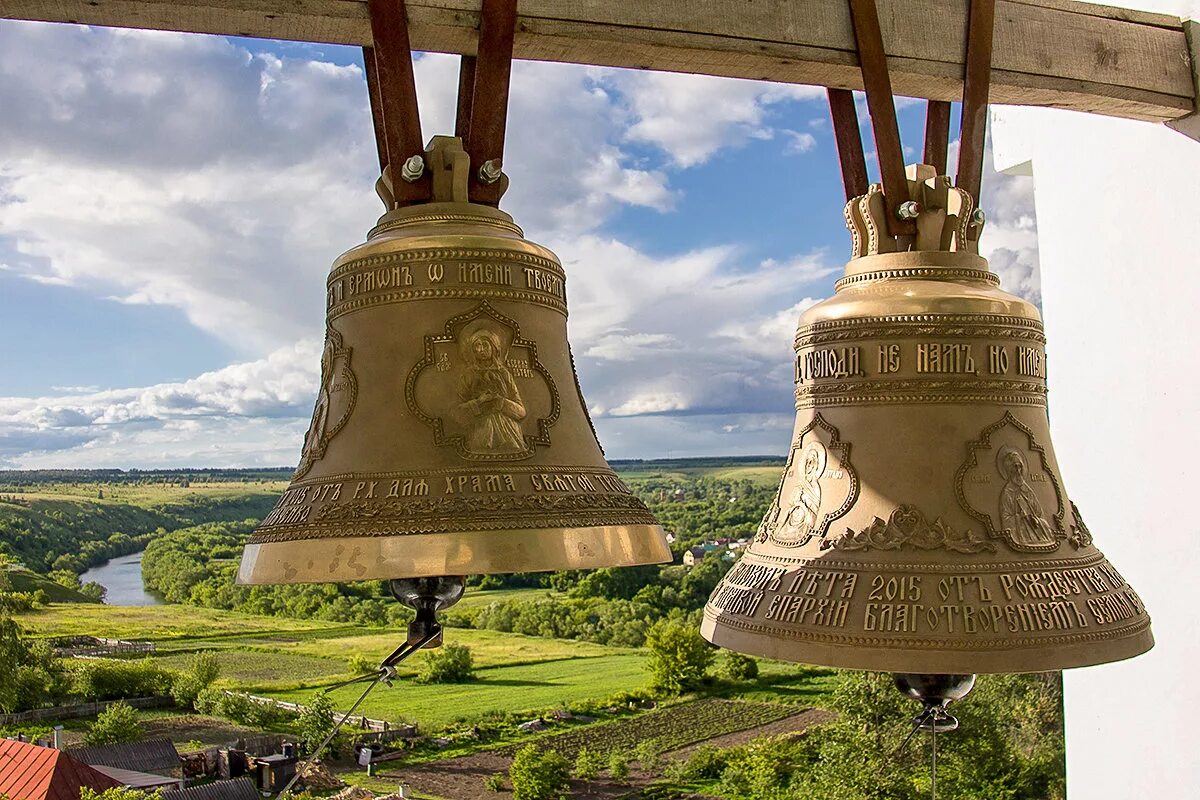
[455,329,526,453]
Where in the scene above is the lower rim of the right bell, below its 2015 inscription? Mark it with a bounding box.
[700,609,1154,674]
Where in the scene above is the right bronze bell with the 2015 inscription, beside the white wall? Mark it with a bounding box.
[702,166,1153,674]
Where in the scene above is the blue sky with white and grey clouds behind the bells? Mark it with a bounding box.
[0,20,1039,469]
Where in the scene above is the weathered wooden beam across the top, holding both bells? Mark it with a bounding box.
[0,0,1195,121]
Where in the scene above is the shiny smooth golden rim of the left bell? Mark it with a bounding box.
[229,523,673,585]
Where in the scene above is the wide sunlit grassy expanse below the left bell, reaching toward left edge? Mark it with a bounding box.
[17,604,646,727]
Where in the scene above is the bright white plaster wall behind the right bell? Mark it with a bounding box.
[992,108,1200,800]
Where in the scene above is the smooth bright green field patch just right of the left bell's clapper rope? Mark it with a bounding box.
[265,652,647,728]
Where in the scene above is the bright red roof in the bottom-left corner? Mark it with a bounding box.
[0,739,121,800]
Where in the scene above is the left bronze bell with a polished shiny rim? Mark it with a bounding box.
[239,137,671,583]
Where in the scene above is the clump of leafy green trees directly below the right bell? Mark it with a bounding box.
[696,673,1064,800]
